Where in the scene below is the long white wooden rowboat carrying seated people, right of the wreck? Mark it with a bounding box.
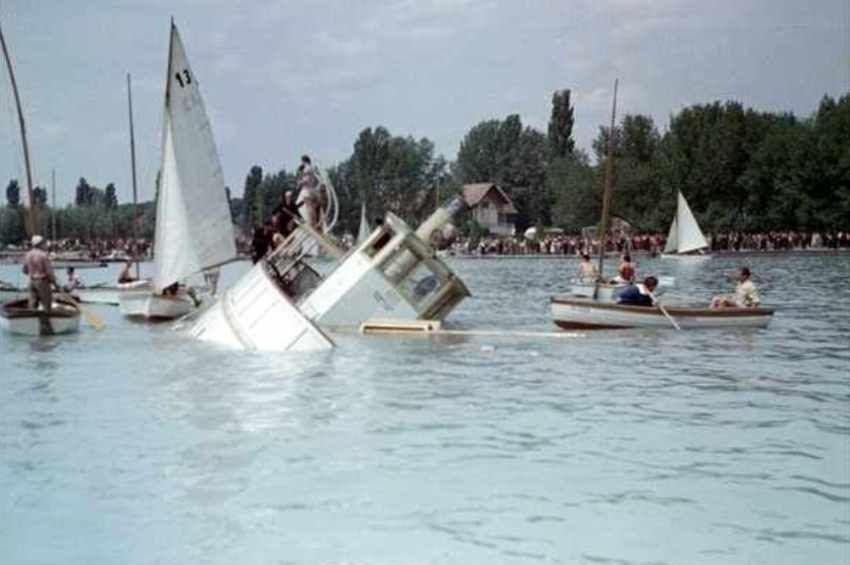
[552,295,774,330]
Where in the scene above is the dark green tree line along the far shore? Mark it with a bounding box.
[0,90,850,243]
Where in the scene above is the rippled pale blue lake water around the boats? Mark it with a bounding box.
[0,254,850,565]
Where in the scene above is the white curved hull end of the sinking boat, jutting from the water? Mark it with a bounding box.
[189,261,334,351]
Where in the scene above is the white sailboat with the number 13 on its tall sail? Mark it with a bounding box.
[120,21,236,319]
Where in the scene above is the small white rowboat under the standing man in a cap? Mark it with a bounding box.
[0,298,80,336]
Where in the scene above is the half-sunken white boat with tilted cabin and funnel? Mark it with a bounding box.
[189,197,470,351]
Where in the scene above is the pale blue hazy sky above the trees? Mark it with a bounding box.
[0,0,850,205]
